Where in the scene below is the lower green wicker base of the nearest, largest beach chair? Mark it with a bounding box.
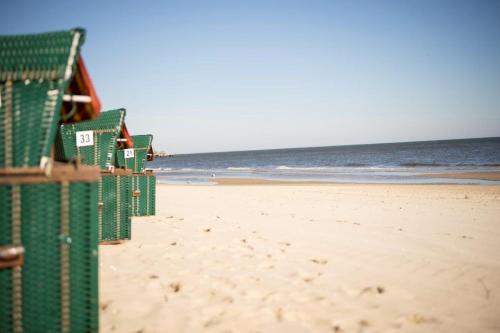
[0,165,99,333]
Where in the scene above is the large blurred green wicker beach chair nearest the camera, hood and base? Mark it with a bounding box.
[0,29,100,332]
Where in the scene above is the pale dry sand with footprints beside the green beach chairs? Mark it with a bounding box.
[100,185,500,332]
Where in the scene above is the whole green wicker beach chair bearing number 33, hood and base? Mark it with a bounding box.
[56,109,133,242]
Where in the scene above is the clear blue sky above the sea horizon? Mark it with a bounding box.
[0,0,500,153]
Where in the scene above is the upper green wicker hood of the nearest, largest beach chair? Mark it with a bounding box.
[0,29,100,168]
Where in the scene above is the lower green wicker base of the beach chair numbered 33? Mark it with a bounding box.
[98,169,132,242]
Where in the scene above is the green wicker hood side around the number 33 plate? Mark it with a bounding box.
[56,109,125,169]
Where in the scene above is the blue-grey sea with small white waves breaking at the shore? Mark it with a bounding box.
[147,137,500,185]
